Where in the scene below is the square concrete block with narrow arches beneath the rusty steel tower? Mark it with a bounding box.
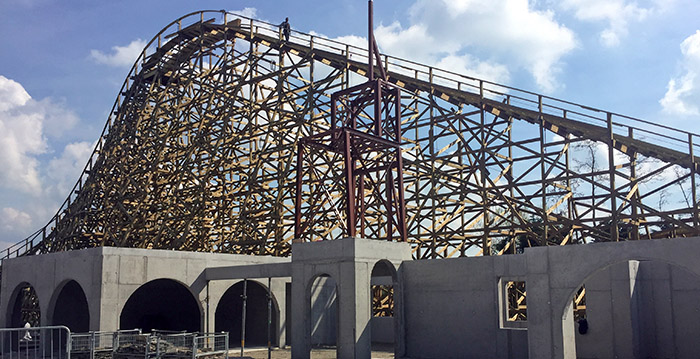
[292,238,411,359]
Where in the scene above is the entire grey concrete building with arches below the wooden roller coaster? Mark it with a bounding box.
[0,238,700,358]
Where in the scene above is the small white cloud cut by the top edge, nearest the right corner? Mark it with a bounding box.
[561,0,669,47]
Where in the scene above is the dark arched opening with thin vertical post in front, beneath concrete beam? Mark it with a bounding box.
[214,280,279,347]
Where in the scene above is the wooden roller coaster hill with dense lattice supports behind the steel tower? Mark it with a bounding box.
[4,11,698,259]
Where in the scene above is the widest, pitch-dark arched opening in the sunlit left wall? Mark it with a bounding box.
[119,279,201,332]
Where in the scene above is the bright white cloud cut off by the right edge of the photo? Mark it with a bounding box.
[659,30,700,116]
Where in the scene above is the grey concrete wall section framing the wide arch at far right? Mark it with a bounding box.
[525,238,700,358]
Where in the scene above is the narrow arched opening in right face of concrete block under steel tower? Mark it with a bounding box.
[370,260,397,353]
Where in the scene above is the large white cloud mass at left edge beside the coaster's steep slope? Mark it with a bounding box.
[0,75,94,246]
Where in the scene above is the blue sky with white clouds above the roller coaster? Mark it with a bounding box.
[0,0,700,248]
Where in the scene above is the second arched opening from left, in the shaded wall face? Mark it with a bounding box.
[51,280,90,333]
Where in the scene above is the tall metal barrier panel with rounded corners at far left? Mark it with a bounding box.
[0,326,71,359]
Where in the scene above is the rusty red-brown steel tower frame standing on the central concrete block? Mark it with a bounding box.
[294,75,407,241]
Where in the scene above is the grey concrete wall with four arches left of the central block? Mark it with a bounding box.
[0,247,290,344]
